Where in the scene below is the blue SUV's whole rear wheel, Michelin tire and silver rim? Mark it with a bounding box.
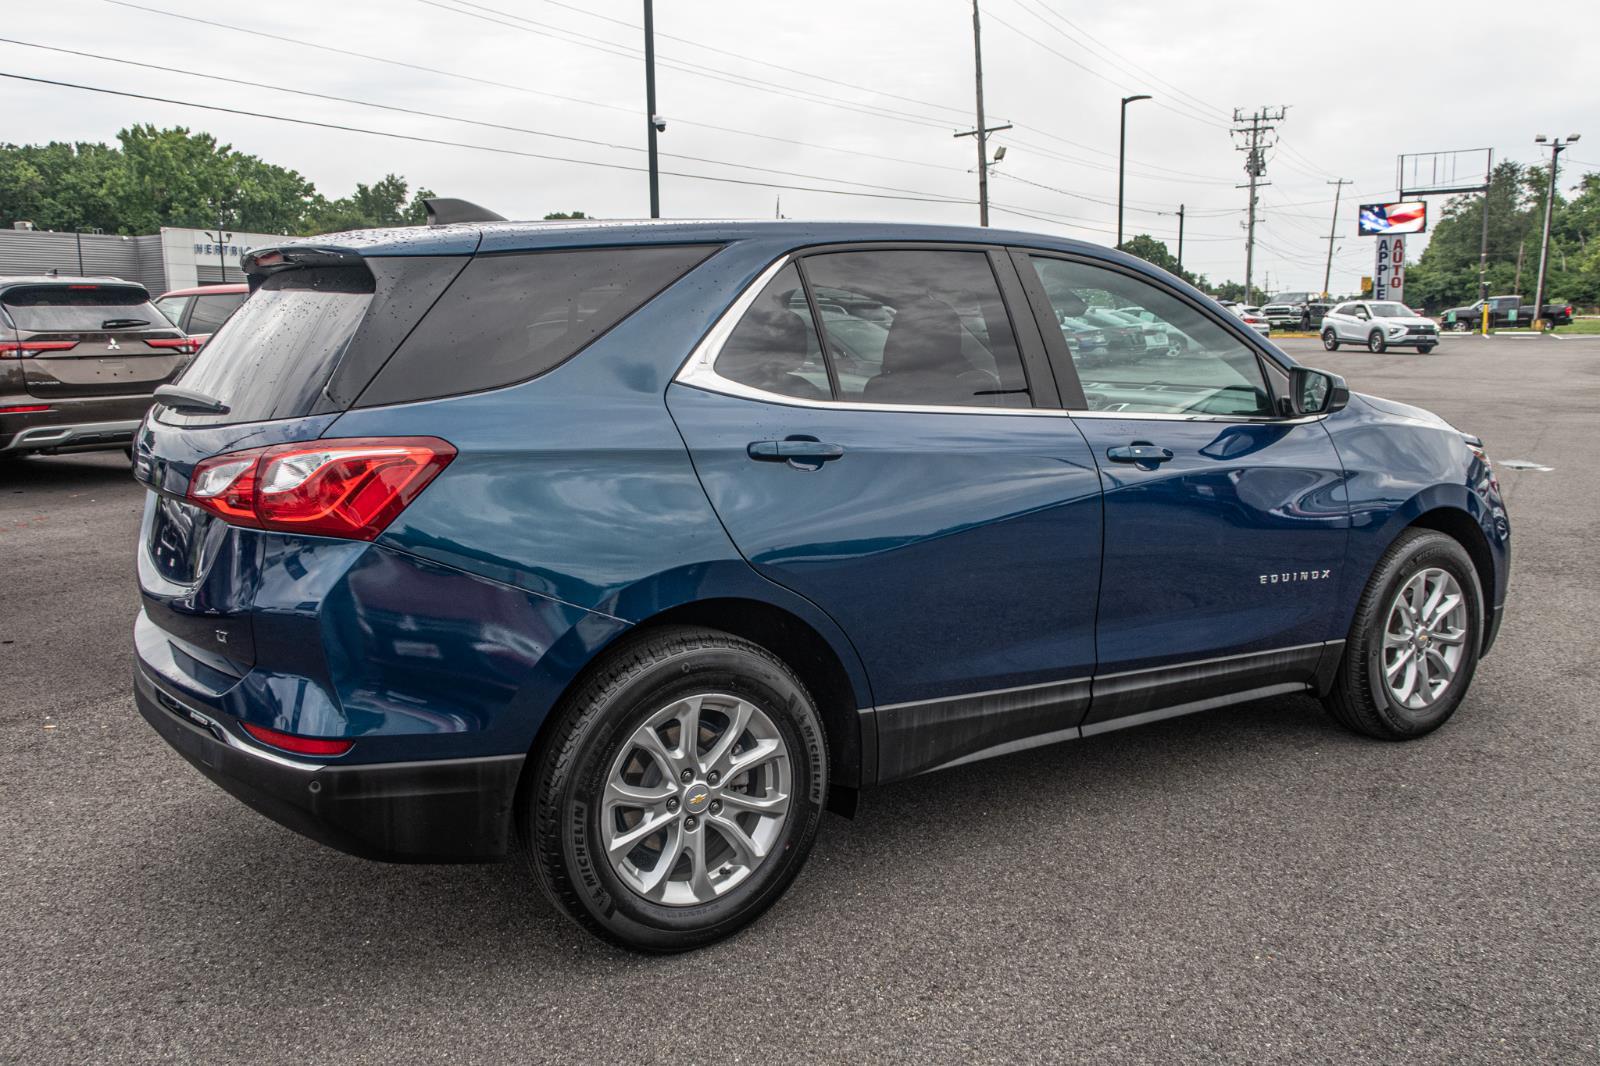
[518,617,827,952]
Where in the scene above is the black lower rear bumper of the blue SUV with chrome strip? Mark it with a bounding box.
[133,666,525,863]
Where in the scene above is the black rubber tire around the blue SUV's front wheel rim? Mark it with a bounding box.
[1322,530,1483,741]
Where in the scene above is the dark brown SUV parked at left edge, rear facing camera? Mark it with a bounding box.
[0,277,197,458]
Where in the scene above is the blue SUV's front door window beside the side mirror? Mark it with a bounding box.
[1030,256,1272,416]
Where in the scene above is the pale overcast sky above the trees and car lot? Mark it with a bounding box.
[0,0,1600,291]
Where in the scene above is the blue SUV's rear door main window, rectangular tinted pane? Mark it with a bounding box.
[802,250,1032,407]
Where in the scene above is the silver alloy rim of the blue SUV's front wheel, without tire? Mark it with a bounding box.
[1382,567,1469,711]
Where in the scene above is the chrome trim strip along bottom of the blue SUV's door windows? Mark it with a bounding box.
[672,253,1326,426]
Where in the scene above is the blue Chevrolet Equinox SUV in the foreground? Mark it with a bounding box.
[134,214,1509,951]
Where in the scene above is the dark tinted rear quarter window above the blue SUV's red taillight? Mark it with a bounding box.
[358,245,715,407]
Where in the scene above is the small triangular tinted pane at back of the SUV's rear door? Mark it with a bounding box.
[717,264,832,400]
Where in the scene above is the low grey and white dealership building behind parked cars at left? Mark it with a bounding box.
[0,222,286,295]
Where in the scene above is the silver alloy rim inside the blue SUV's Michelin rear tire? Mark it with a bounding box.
[600,693,794,906]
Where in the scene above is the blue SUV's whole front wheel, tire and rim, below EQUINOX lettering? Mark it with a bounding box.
[1323,530,1483,739]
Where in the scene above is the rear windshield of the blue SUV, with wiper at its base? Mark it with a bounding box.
[163,267,373,424]
